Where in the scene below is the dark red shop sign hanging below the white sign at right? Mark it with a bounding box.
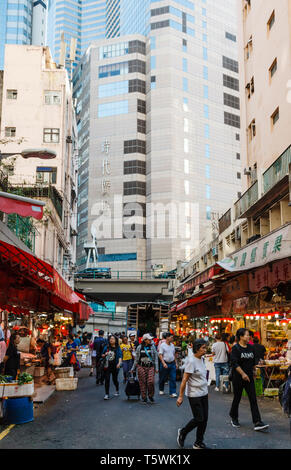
[249,255,291,292]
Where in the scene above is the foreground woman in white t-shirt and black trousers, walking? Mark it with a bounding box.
[177,339,208,449]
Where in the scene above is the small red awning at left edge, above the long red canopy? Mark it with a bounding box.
[0,191,45,220]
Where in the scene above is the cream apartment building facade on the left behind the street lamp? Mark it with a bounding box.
[1,45,78,282]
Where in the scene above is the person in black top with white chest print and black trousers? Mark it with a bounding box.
[229,328,269,431]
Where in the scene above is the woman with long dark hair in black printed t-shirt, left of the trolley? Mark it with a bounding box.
[102,335,122,400]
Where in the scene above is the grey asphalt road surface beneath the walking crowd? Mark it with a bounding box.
[0,369,291,449]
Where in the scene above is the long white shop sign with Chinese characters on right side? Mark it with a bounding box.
[217,224,291,272]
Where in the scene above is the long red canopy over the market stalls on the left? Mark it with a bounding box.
[0,241,93,320]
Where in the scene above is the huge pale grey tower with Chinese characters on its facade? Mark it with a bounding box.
[75,0,242,269]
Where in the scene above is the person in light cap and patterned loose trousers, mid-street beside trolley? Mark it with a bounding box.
[131,333,158,403]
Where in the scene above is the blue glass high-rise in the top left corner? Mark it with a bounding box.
[0,0,48,69]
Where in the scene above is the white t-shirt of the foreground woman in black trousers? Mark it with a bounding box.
[184,355,208,398]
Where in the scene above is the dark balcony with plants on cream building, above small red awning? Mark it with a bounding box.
[8,184,63,221]
